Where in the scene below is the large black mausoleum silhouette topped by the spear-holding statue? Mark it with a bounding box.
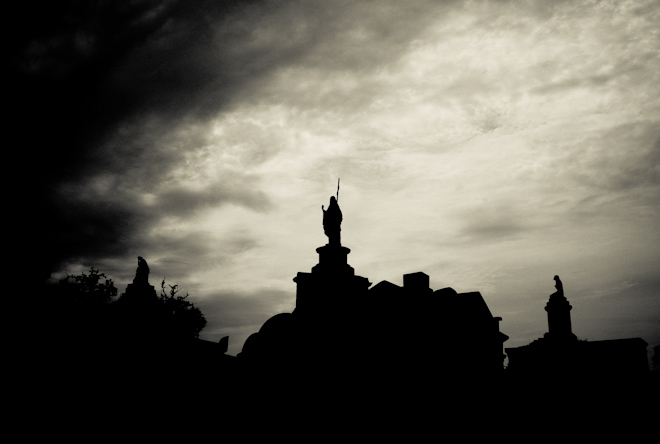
[238,197,508,378]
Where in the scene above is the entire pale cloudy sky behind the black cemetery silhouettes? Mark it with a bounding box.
[16,0,660,355]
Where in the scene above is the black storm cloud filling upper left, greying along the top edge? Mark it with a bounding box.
[20,0,458,276]
